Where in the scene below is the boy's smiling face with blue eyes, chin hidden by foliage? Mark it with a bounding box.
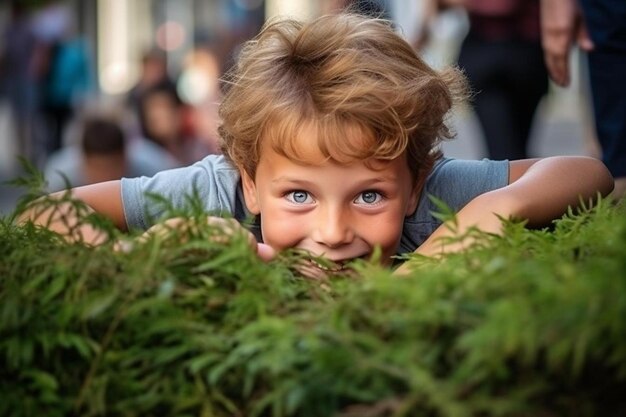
[242,126,417,264]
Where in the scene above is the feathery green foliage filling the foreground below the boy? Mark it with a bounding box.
[0,189,626,417]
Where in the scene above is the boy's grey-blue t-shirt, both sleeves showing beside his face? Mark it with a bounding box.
[122,155,509,254]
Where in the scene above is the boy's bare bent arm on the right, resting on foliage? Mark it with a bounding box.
[416,156,613,256]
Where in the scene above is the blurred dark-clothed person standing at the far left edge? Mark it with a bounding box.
[0,0,40,164]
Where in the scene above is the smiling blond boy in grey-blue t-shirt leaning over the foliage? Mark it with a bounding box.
[23,14,613,268]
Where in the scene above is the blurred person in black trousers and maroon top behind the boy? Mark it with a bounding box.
[416,0,548,159]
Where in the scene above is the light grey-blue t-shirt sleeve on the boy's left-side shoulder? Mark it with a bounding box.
[121,155,239,230]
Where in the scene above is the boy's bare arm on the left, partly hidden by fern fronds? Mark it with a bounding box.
[19,181,126,244]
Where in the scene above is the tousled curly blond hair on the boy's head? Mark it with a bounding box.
[219,13,466,182]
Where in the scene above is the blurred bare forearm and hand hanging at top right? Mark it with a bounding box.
[541,0,593,87]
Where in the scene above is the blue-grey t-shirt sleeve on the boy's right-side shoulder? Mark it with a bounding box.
[400,158,509,253]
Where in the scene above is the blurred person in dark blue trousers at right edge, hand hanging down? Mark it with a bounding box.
[541,0,626,198]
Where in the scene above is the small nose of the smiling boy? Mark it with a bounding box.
[313,207,354,248]
